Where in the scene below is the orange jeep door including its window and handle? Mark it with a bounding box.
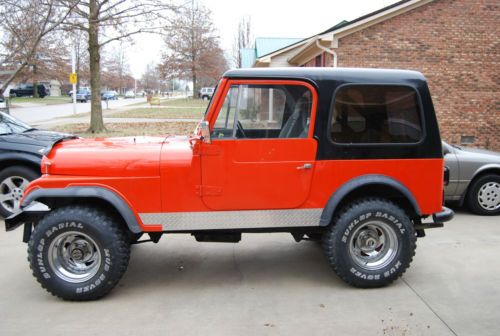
[199,80,317,210]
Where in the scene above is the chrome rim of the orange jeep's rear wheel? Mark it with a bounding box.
[349,221,399,270]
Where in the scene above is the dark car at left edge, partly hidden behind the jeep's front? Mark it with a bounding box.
[0,112,75,217]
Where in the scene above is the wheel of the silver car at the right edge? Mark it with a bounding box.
[467,174,500,216]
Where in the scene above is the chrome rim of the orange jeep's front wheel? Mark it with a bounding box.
[48,231,102,283]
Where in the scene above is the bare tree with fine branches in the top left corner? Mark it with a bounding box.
[0,0,78,96]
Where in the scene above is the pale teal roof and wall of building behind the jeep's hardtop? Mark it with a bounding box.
[240,37,303,68]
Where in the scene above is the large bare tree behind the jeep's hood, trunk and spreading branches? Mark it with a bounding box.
[60,0,175,133]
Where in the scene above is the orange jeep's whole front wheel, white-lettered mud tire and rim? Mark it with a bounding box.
[28,206,130,301]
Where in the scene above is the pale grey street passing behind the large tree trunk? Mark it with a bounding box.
[10,98,146,125]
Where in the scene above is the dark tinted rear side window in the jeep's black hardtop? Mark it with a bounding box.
[330,85,423,143]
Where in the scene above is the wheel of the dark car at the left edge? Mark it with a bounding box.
[0,166,40,218]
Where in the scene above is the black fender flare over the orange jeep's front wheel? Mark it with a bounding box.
[21,187,143,233]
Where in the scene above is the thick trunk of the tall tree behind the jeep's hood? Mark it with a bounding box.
[88,0,106,133]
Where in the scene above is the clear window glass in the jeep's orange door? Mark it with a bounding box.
[212,85,312,139]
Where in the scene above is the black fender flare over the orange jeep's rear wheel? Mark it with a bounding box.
[319,174,421,226]
